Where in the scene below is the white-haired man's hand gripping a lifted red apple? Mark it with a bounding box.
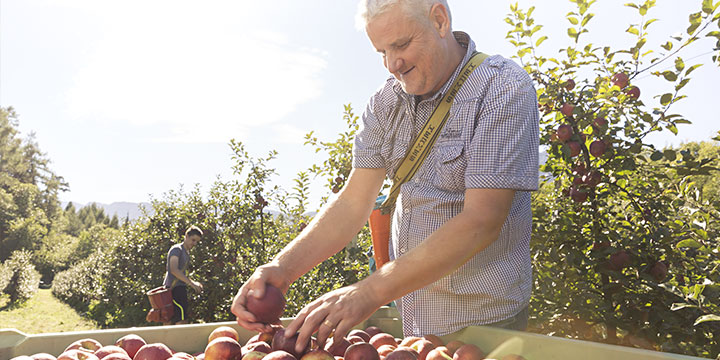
[230,263,290,332]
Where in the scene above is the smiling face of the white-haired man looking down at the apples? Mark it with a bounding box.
[365,5,446,98]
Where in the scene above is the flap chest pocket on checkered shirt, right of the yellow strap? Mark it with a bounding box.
[433,142,467,192]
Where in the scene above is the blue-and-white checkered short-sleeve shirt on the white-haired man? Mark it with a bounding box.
[353,32,539,336]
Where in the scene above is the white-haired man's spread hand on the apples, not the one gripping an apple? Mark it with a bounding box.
[285,281,384,352]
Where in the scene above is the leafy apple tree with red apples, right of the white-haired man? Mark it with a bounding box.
[506,0,720,356]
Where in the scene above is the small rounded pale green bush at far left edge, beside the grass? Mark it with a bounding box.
[0,250,40,305]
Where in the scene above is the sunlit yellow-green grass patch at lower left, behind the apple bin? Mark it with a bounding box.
[0,289,100,334]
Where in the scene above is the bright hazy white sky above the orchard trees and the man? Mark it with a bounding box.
[0,0,720,210]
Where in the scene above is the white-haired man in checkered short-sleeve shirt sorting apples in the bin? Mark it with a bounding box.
[232,0,539,347]
